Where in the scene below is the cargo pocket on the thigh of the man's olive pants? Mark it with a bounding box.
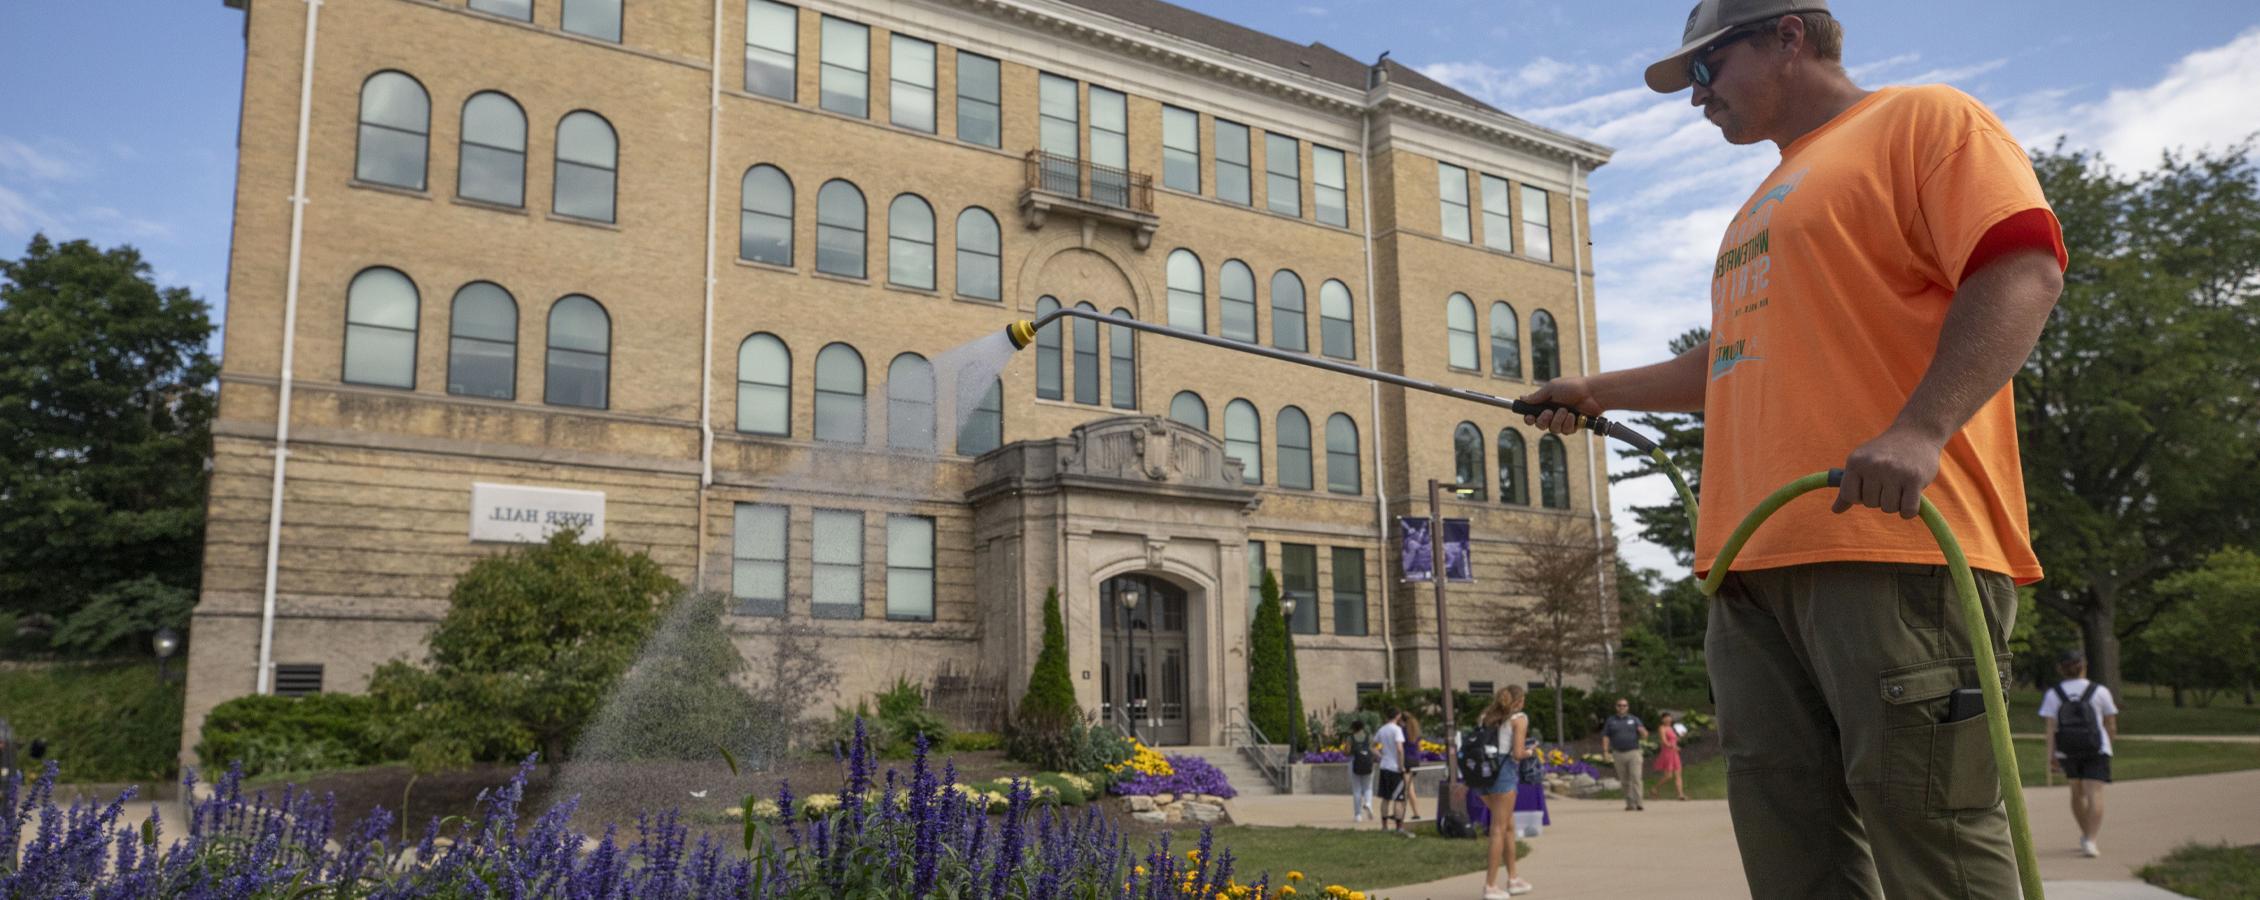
[1878,656,2009,814]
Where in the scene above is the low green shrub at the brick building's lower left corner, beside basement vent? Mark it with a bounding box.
[197,694,386,776]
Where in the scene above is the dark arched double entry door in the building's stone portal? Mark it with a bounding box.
[1098,574,1191,744]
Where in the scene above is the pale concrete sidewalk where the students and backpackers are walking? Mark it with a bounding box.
[1232,771,2260,900]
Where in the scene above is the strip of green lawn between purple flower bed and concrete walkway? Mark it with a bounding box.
[1168,825,1530,895]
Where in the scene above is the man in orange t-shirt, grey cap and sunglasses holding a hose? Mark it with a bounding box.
[1526,0,2066,898]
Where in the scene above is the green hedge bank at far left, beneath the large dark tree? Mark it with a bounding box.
[0,660,183,782]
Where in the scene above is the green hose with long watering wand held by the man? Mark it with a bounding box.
[1003,308,2043,900]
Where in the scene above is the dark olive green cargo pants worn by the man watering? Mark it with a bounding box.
[1704,563,2018,900]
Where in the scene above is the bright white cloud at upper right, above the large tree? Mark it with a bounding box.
[2002,27,2260,170]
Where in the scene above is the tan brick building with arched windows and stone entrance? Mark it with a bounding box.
[185,0,1609,759]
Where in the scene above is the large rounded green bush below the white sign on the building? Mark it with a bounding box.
[368,529,683,769]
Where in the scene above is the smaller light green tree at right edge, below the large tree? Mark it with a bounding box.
[2142,547,2260,706]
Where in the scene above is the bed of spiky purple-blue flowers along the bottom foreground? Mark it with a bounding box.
[0,728,1319,900]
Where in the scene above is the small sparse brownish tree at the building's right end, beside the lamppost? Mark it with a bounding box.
[1494,518,1616,739]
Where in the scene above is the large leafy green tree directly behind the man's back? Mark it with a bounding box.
[2016,142,2260,685]
